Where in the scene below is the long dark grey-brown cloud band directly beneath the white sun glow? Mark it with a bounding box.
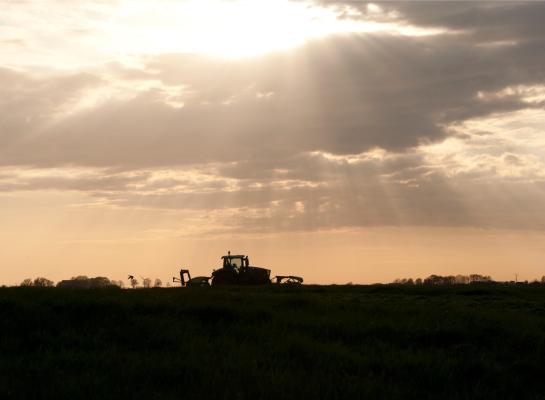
[0,27,545,167]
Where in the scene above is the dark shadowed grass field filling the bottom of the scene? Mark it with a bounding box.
[0,286,545,399]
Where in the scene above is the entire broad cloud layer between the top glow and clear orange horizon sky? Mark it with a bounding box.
[0,2,545,230]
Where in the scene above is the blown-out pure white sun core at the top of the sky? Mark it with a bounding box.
[105,0,437,58]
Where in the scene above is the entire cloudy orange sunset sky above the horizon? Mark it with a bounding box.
[0,0,545,284]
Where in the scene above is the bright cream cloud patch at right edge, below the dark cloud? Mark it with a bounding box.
[420,108,545,183]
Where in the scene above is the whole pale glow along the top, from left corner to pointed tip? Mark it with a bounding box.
[0,0,446,69]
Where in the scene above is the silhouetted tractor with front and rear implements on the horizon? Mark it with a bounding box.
[172,251,303,287]
